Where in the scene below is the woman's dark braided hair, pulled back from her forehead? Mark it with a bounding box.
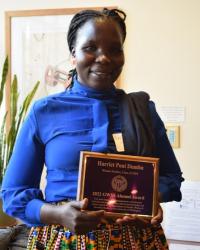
[67,8,126,87]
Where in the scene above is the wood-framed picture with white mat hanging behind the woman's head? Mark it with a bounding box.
[5,7,116,123]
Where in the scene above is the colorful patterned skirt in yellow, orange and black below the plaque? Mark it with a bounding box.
[27,224,169,250]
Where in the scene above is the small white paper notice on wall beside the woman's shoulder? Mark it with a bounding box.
[159,106,185,123]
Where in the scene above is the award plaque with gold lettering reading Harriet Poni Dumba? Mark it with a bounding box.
[77,151,159,218]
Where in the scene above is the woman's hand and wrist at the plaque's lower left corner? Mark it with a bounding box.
[41,199,104,234]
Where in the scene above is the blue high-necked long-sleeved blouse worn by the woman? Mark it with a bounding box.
[2,80,183,226]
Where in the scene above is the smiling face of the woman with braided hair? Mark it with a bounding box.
[72,19,124,90]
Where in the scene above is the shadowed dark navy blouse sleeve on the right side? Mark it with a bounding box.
[149,101,184,202]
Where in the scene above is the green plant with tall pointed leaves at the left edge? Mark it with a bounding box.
[0,57,39,185]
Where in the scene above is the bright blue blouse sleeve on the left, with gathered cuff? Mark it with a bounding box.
[2,103,44,226]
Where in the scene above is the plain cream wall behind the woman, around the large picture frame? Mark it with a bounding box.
[0,0,200,180]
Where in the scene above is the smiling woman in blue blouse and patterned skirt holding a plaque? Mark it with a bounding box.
[2,9,183,249]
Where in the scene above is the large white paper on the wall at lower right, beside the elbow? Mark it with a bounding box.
[163,181,200,242]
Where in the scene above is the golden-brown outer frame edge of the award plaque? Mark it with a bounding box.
[77,151,159,218]
